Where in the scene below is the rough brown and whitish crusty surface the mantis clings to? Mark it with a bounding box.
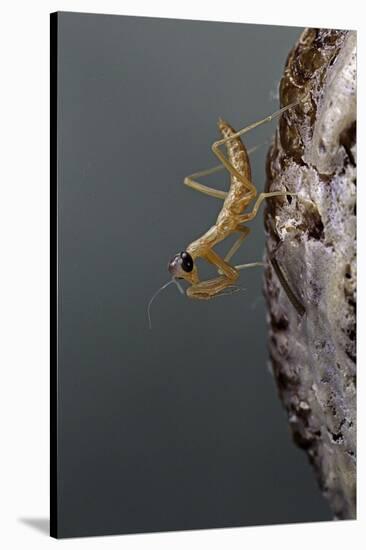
[265,29,356,518]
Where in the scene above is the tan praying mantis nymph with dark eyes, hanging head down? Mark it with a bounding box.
[148,101,299,325]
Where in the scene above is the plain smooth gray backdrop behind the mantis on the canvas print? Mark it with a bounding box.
[58,13,331,536]
